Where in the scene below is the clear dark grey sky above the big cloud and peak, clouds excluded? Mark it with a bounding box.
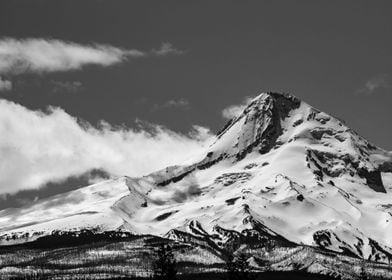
[0,0,392,206]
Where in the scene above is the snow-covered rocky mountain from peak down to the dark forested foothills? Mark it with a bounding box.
[0,93,392,261]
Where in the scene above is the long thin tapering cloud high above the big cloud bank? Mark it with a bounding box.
[0,38,145,75]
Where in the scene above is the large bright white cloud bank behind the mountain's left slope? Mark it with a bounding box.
[0,99,212,193]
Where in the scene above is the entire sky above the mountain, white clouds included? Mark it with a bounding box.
[0,0,392,208]
